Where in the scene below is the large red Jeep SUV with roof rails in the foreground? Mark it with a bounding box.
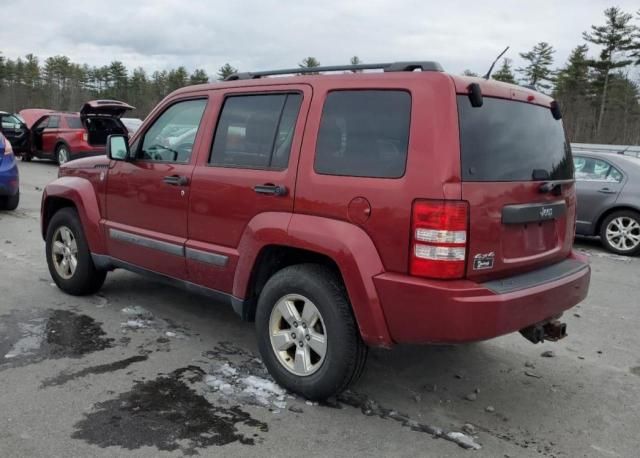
[42,62,590,399]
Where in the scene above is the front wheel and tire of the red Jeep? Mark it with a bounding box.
[46,208,107,296]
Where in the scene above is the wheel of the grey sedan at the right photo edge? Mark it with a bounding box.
[600,210,640,256]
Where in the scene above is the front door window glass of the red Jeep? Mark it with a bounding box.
[137,99,207,163]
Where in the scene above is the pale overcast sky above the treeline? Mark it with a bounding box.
[0,0,640,75]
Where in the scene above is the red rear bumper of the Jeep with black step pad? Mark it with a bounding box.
[374,254,591,343]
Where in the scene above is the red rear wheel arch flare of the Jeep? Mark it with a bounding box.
[233,213,393,347]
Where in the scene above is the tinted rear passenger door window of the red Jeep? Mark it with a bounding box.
[209,93,302,170]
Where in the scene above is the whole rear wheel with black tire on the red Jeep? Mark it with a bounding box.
[256,264,367,400]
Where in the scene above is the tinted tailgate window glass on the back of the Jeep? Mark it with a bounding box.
[458,95,573,181]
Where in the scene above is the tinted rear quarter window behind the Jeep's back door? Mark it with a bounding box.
[314,90,411,178]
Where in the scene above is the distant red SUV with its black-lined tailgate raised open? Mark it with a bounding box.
[20,100,134,164]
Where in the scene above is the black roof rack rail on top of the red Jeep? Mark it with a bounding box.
[225,61,444,81]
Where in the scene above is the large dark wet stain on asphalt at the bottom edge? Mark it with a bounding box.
[72,366,269,455]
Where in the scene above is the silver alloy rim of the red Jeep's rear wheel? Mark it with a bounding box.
[269,294,327,377]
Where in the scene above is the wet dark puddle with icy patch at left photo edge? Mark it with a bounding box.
[0,310,113,368]
